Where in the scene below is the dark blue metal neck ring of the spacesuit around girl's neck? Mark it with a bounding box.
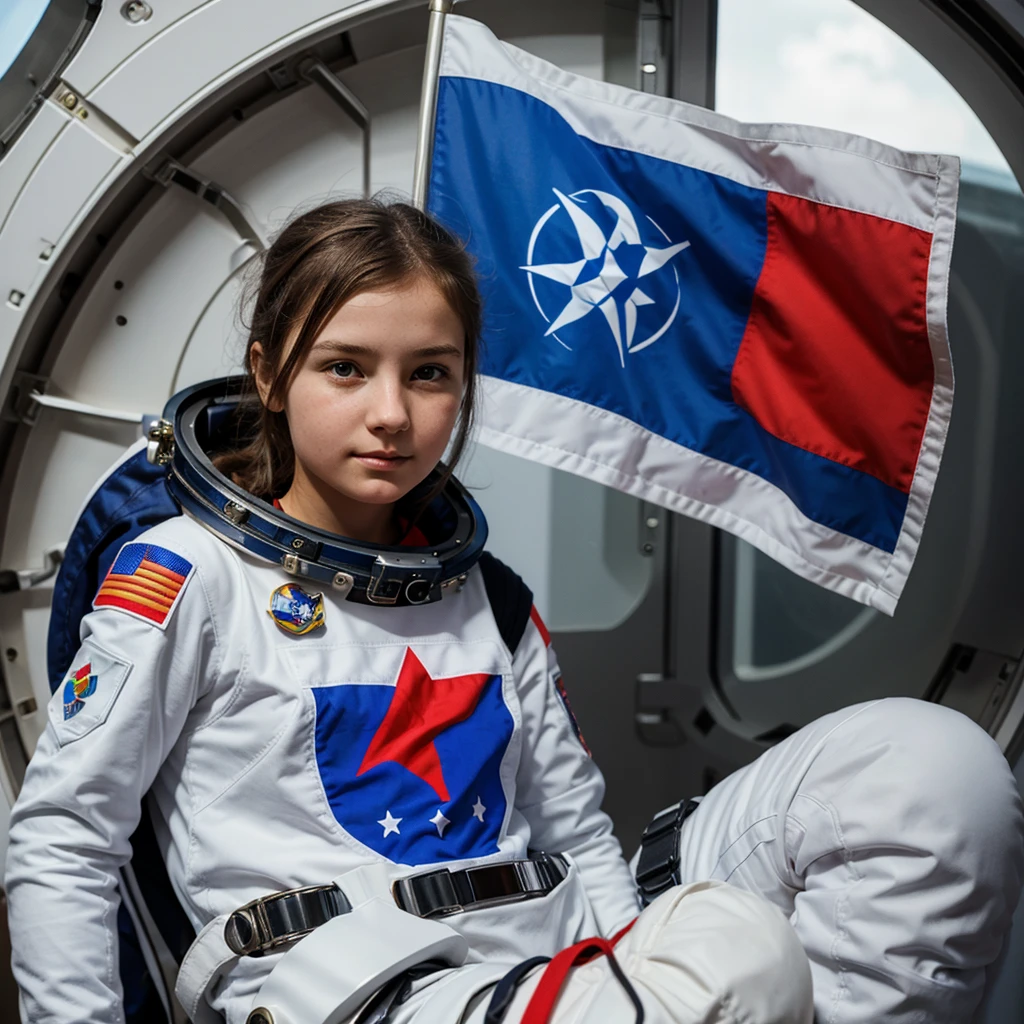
[146,376,487,606]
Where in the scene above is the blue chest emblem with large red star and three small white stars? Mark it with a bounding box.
[313,649,513,864]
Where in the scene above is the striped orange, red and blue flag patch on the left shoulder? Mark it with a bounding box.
[92,544,195,629]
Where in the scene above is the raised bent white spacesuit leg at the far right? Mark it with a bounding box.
[667,698,1024,1024]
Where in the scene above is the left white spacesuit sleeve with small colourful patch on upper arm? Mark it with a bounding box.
[5,532,219,1024]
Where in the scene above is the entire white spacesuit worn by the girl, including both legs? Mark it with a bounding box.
[6,385,1024,1024]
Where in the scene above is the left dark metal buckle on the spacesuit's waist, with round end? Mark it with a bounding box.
[224,885,351,956]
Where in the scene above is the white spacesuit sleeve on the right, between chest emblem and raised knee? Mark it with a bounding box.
[513,611,639,935]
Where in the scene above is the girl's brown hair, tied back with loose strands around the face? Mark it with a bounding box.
[214,198,481,501]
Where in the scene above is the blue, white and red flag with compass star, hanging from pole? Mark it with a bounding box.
[429,16,959,614]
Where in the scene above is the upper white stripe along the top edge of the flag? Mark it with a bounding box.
[441,14,959,231]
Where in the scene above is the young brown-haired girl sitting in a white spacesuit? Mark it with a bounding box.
[6,201,1021,1024]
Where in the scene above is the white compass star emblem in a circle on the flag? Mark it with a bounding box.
[519,188,689,368]
